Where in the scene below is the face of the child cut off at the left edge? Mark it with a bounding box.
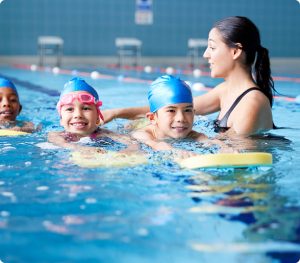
[0,87,21,122]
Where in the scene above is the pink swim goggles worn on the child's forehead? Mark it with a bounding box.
[56,93,104,121]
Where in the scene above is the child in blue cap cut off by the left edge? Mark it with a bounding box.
[0,77,34,132]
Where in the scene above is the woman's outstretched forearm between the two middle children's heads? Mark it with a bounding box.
[102,106,149,123]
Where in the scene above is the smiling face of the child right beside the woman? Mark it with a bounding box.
[152,103,194,139]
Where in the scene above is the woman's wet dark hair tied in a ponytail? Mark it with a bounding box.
[214,16,276,105]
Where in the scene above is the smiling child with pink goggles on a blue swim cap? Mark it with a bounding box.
[48,78,137,152]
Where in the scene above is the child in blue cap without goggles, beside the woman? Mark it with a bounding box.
[132,75,229,154]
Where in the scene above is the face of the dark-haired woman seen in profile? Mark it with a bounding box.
[203,28,235,78]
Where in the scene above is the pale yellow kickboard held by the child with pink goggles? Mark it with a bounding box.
[71,151,148,168]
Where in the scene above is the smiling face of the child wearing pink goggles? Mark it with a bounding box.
[60,92,99,136]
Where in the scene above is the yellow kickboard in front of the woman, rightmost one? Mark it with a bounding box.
[179,152,273,169]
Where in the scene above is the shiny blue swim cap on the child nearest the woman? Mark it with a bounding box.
[148,75,193,112]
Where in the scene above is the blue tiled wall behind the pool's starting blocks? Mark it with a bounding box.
[0,0,300,57]
